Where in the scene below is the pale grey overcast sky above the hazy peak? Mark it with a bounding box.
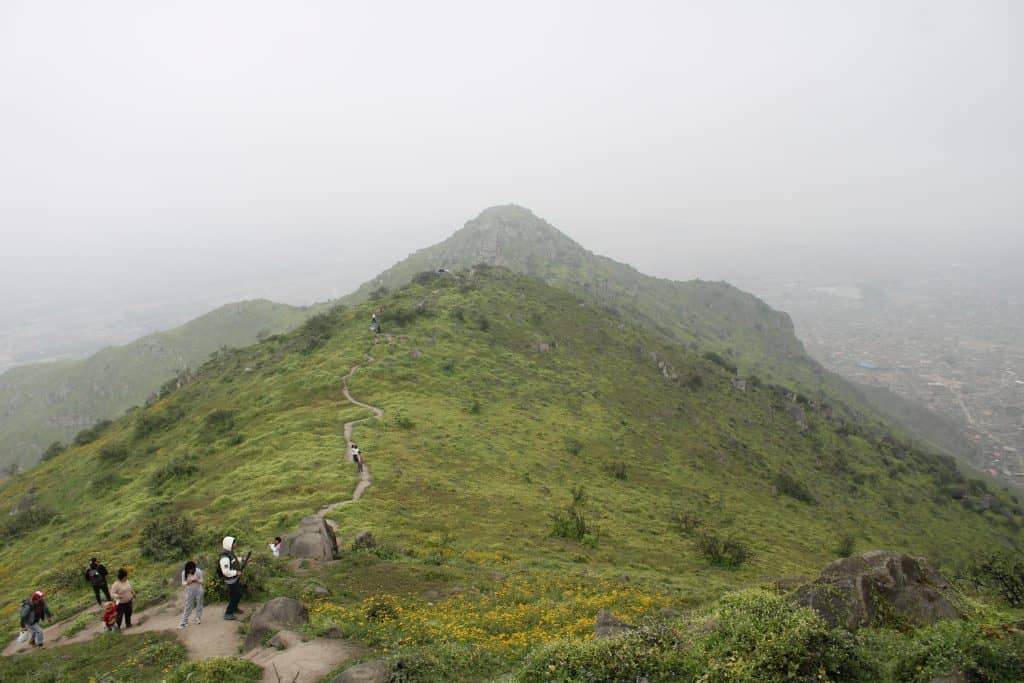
[0,0,1024,321]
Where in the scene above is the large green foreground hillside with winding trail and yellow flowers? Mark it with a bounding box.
[0,268,1024,680]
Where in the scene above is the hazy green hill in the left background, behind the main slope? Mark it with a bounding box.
[0,300,315,469]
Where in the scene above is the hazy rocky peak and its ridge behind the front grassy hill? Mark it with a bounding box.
[341,205,987,471]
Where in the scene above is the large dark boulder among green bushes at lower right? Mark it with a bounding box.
[795,550,959,631]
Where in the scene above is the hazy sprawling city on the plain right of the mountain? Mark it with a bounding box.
[745,255,1024,484]
